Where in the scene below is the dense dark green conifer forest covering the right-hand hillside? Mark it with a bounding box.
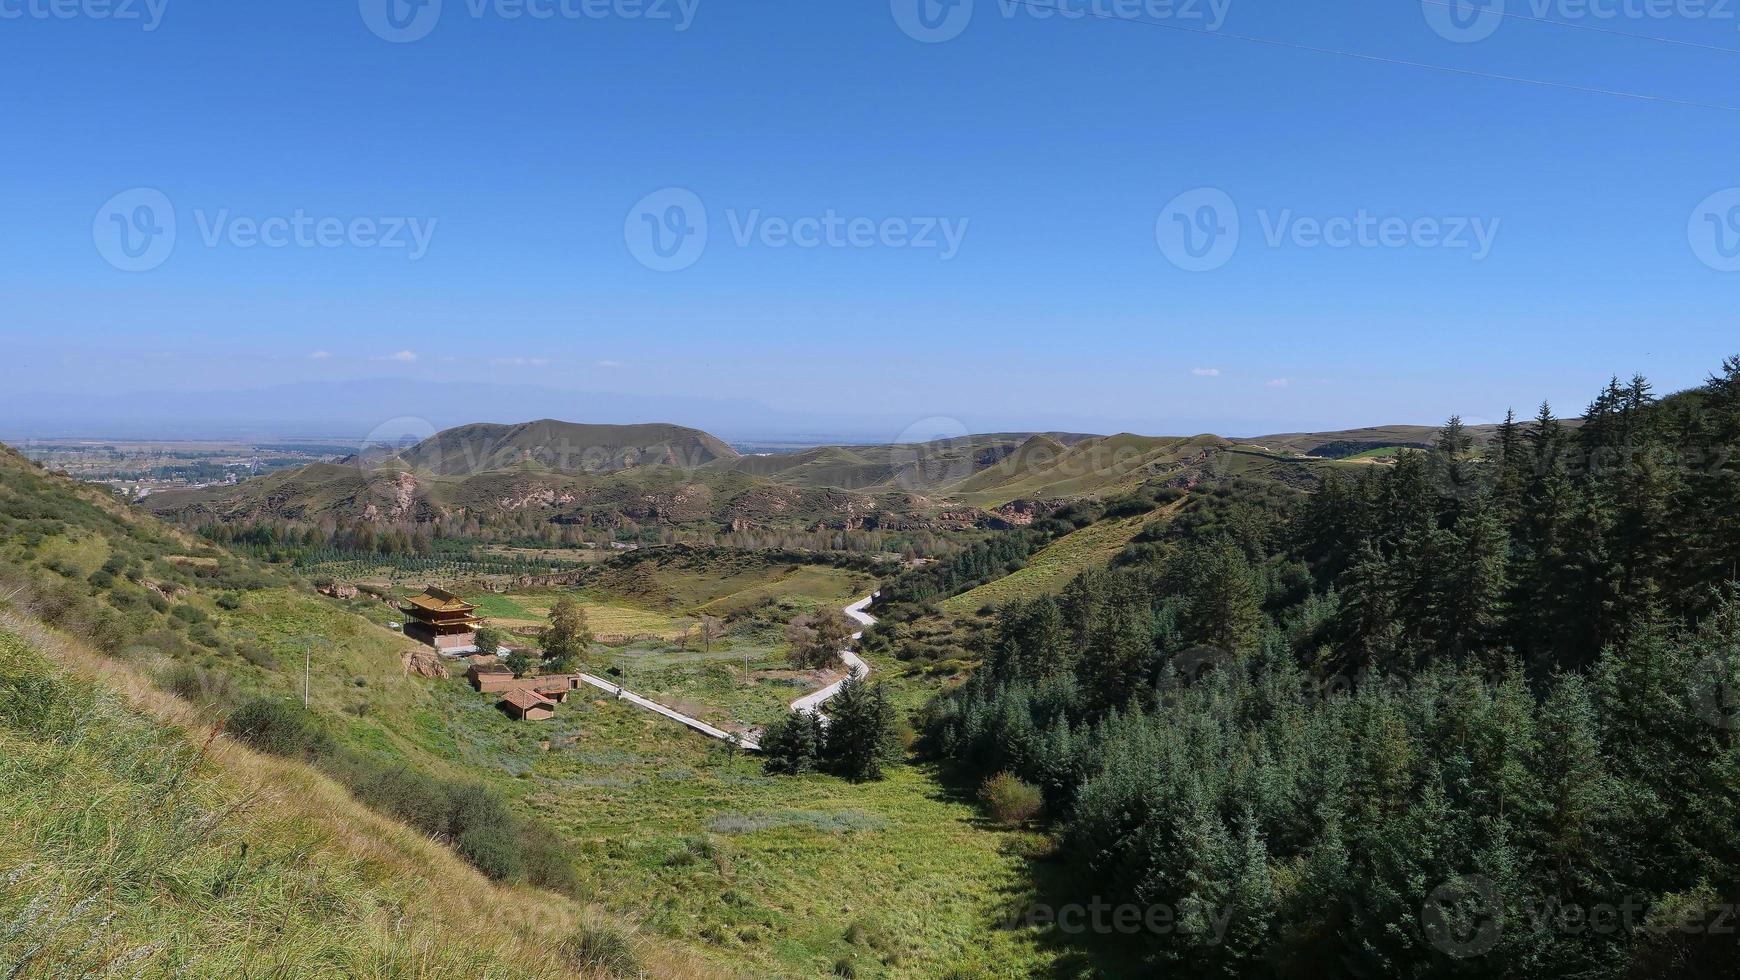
[926,359,1740,977]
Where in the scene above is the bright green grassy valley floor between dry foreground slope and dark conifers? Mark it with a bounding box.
[504,689,1053,978]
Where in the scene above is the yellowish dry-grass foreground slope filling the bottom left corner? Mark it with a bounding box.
[0,614,720,978]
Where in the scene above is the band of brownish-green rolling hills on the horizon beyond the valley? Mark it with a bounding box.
[144,420,1461,531]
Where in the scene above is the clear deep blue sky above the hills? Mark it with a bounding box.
[0,0,1740,435]
